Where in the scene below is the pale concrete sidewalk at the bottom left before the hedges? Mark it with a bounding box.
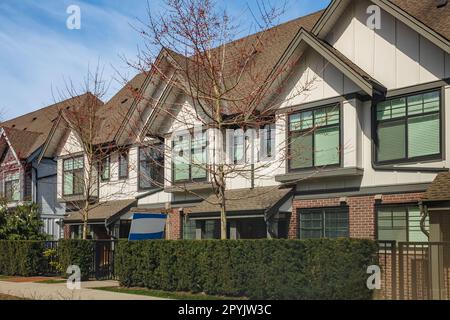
[0,281,164,300]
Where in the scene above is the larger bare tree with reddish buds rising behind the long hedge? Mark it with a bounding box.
[128,0,324,239]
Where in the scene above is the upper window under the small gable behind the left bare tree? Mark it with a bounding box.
[63,156,84,196]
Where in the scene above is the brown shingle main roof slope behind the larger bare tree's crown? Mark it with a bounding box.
[164,10,323,114]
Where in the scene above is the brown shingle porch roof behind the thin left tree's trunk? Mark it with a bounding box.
[64,199,137,223]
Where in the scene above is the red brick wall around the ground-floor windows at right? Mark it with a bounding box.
[288,193,422,239]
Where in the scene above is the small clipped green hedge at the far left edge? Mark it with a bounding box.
[0,240,47,277]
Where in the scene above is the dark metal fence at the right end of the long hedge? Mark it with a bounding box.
[378,241,450,300]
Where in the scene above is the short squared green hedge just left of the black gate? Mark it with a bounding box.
[57,240,94,280]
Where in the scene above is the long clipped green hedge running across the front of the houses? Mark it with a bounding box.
[115,239,377,299]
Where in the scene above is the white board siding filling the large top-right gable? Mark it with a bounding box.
[326,0,449,89]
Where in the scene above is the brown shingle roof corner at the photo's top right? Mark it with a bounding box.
[390,0,450,40]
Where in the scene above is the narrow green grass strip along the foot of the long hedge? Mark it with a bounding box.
[95,287,244,300]
